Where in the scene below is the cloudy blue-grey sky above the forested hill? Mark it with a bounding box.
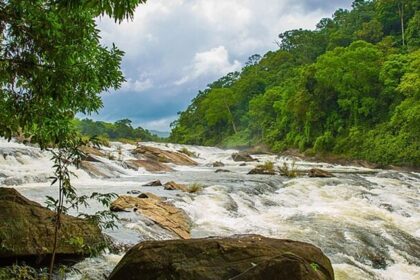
[88,0,352,131]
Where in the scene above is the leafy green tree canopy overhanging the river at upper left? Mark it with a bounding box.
[0,0,144,146]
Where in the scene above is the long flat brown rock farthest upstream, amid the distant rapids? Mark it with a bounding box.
[133,145,197,166]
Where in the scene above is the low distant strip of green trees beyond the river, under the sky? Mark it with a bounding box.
[74,119,162,142]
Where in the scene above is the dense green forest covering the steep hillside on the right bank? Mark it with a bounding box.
[170,0,420,166]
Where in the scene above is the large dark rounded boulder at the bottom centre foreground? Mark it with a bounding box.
[109,235,334,280]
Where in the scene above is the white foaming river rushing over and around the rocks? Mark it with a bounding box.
[0,140,420,280]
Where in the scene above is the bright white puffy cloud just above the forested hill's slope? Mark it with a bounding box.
[175,46,241,86]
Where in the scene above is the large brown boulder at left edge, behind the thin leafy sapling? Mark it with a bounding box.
[0,187,104,263]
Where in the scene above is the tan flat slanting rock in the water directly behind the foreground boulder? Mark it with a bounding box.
[111,193,191,239]
